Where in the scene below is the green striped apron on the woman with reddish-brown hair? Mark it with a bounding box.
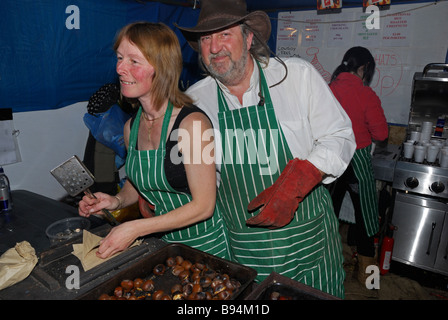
[126,103,230,259]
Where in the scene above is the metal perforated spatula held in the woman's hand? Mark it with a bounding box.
[50,156,120,226]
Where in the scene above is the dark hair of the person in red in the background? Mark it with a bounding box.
[331,47,376,85]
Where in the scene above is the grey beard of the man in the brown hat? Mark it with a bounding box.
[206,45,249,85]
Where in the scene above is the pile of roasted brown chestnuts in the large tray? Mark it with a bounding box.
[99,256,241,300]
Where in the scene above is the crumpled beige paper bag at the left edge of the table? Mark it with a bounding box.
[0,241,38,290]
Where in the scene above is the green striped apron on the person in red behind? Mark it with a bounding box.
[351,145,379,237]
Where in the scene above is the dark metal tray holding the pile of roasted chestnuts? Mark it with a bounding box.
[79,243,257,300]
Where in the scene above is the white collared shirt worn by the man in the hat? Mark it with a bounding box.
[187,58,356,183]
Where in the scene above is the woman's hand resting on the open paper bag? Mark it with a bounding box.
[96,220,139,259]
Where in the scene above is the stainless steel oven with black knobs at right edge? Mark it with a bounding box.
[392,64,448,275]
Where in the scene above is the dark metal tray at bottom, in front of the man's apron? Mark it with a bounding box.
[245,272,339,300]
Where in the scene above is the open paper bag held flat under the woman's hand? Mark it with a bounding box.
[72,230,141,271]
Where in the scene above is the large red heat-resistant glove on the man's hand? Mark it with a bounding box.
[246,158,322,229]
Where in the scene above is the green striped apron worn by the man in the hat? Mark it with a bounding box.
[218,63,345,298]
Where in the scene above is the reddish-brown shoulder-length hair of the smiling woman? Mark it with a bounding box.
[114,22,193,109]
